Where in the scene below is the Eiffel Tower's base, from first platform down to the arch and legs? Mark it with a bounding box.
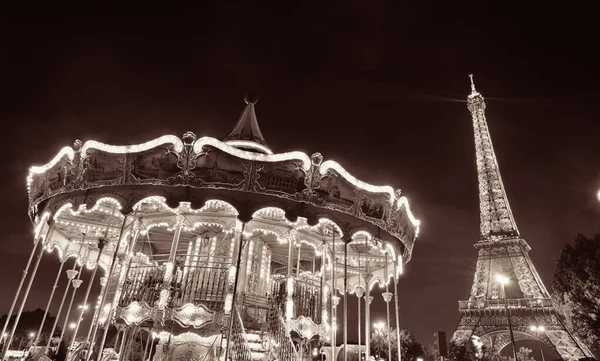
[452,306,593,361]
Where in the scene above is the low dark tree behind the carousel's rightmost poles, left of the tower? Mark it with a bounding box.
[371,328,425,361]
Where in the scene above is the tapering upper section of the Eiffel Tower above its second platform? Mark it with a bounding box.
[467,74,519,242]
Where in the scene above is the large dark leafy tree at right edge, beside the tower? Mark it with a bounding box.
[552,234,600,355]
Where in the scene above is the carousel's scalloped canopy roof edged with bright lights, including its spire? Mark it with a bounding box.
[27,99,420,263]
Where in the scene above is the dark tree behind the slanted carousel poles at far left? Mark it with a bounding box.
[0,308,60,349]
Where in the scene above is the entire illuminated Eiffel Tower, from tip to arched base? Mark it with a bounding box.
[452,75,593,361]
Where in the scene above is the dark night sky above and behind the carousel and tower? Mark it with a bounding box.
[0,0,600,352]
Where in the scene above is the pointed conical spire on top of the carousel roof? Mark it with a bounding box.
[223,95,273,154]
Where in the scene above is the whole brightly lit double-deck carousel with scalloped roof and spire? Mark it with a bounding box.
[2,100,419,361]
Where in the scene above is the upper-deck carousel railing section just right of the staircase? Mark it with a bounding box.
[271,273,323,324]
